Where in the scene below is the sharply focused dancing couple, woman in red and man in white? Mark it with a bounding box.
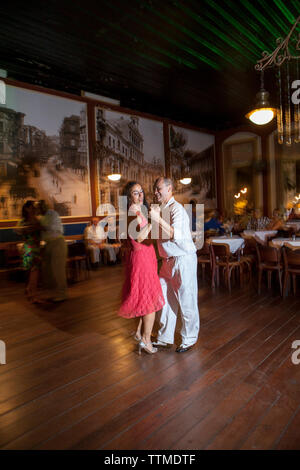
[119,177,200,354]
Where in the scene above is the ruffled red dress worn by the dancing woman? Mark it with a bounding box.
[119,207,165,318]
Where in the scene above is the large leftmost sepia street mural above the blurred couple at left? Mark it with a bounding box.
[0,86,91,220]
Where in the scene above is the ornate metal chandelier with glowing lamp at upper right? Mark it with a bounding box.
[246,16,300,145]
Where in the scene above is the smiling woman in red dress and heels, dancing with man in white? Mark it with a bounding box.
[119,181,165,354]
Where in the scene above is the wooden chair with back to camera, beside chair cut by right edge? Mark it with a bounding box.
[256,243,283,295]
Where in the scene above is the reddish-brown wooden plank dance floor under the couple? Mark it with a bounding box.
[0,266,300,450]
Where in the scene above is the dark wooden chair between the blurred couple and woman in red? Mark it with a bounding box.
[67,242,91,281]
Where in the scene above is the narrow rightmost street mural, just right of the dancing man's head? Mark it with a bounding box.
[169,125,216,210]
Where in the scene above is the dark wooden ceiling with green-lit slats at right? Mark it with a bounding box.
[0,0,300,130]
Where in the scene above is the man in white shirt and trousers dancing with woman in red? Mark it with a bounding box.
[151,177,200,353]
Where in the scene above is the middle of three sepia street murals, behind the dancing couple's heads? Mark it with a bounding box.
[96,108,165,207]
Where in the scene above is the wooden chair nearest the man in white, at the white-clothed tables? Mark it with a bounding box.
[210,242,244,292]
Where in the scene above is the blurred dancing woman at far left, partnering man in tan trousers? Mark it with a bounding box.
[17,201,41,303]
